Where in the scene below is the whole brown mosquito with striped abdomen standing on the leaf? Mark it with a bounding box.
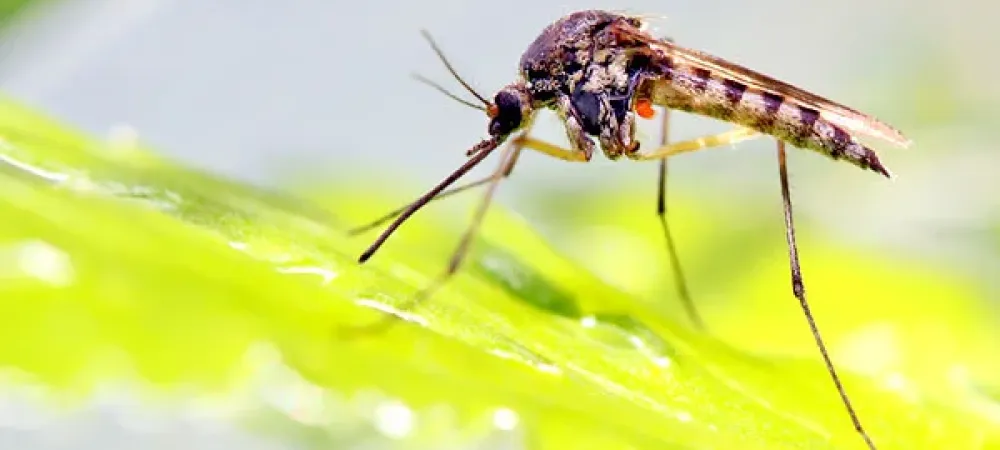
[352,10,910,450]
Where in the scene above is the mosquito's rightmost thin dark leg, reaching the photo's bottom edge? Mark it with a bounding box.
[778,140,875,450]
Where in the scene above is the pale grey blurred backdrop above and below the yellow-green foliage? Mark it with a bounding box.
[0,0,1000,449]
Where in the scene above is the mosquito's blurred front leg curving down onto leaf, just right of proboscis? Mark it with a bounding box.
[342,144,520,337]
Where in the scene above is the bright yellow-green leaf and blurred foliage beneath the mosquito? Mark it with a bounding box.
[0,92,1000,449]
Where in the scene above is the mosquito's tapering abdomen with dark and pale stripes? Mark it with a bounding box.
[640,60,890,177]
